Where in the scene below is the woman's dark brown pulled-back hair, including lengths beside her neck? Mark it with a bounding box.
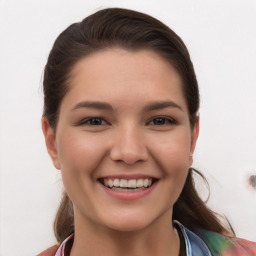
[43,8,234,242]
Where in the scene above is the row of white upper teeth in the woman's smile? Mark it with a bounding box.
[104,178,152,188]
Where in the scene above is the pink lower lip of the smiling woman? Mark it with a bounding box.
[100,181,157,200]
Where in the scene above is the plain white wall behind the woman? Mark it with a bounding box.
[0,0,256,256]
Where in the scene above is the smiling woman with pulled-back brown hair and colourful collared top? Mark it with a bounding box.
[39,8,256,256]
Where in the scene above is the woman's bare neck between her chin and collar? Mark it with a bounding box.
[70,208,180,256]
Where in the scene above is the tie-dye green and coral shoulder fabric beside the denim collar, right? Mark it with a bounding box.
[198,230,256,256]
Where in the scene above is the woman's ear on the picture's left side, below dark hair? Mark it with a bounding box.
[42,116,60,170]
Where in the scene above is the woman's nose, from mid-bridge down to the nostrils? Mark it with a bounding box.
[110,125,148,165]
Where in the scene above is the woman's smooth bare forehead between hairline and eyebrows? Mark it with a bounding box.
[62,48,186,110]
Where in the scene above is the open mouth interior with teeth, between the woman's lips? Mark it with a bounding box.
[99,178,158,192]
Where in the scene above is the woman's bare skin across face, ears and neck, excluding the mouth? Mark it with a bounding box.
[42,48,199,256]
